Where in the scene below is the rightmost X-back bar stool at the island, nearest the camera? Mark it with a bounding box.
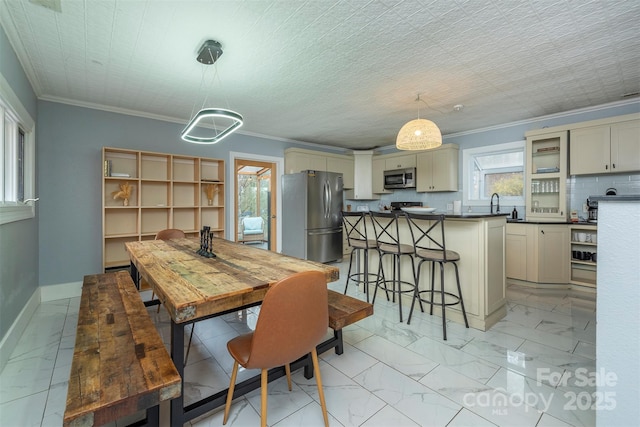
[407,214,469,341]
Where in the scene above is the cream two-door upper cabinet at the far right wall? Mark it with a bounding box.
[569,120,640,175]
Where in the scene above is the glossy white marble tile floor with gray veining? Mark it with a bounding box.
[0,263,596,427]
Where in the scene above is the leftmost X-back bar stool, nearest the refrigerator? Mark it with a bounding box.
[342,212,381,302]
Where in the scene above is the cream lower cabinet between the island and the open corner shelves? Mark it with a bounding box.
[505,223,570,284]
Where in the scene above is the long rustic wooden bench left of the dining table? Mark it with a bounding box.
[64,271,182,426]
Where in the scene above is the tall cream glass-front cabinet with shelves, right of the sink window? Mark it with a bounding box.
[525,131,567,222]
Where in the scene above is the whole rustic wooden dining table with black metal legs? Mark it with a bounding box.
[125,238,339,426]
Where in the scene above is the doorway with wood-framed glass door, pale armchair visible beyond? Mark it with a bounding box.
[234,158,278,251]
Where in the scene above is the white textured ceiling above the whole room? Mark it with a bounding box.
[0,0,640,148]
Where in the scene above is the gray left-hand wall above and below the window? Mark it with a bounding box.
[0,27,39,340]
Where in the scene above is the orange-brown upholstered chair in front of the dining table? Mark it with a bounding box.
[222,271,329,426]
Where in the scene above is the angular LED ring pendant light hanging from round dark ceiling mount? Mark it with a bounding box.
[180,40,243,144]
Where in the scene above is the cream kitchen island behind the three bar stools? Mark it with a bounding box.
[369,214,507,331]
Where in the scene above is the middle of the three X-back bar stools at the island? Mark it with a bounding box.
[371,212,416,322]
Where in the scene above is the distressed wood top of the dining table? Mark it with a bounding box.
[125,239,339,323]
